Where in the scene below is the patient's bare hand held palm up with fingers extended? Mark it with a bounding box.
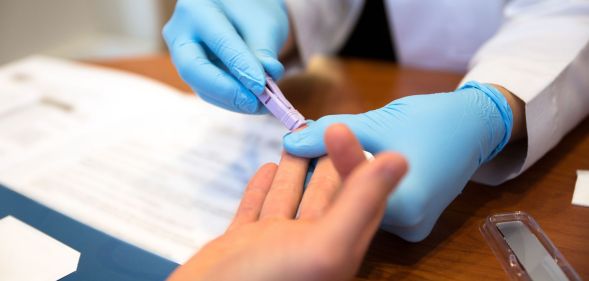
[165,125,407,280]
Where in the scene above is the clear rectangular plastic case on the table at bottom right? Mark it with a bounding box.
[480,211,581,281]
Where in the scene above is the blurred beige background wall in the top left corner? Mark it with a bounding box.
[0,0,175,64]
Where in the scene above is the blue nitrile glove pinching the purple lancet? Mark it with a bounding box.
[163,0,288,113]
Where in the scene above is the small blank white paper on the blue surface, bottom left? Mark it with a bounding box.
[0,216,80,281]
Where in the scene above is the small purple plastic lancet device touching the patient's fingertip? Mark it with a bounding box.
[258,75,305,131]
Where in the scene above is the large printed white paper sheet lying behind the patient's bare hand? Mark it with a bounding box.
[0,57,286,262]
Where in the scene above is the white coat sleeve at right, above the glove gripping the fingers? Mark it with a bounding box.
[461,0,589,185]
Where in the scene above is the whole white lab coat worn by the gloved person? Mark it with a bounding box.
[286,0,589,185]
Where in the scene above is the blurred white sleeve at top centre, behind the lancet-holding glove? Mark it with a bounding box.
[285,0,364,63]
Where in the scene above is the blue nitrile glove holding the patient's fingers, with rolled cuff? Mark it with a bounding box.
[284,82,513,241]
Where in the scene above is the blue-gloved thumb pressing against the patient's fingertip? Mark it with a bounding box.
[283,113,383,158]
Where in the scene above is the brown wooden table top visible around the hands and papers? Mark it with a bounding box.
[97,55,589,280]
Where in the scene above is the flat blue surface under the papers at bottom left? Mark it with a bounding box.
[0,185,178,281]
